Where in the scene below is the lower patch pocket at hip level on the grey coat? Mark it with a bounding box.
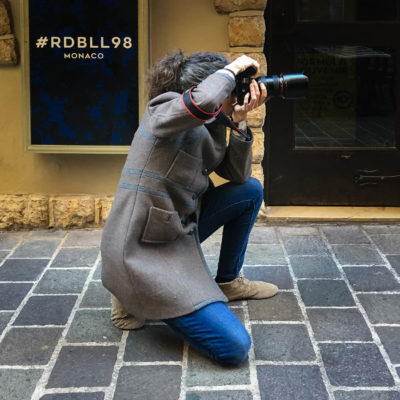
[141,206,182,243]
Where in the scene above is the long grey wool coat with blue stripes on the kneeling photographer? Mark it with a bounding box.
[101,72,253,319]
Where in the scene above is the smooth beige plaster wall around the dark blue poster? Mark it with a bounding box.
[0,0,228,194]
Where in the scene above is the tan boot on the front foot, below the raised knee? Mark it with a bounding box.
[218,275,278,301]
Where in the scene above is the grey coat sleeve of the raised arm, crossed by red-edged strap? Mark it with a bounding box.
[146,71,235,138]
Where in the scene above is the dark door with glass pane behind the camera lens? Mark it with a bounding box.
[264,0,400,206]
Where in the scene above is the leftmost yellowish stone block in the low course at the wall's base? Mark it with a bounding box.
[0,195,28,229]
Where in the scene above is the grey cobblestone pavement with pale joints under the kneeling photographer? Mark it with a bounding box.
[0,224,400,400]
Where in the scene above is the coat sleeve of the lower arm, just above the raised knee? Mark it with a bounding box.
[215,128,254,183]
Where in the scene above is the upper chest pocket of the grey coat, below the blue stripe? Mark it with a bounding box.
[166,150,202,188]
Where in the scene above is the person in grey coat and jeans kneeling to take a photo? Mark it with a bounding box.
[101,52,277,364]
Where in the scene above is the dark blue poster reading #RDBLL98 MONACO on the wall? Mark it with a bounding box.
[29,0,139,146]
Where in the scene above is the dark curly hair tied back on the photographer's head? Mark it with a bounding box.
[147,50,229,100]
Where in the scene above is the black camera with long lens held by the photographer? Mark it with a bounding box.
[234,67,308,105]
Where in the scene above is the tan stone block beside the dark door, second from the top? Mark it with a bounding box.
[228,15,265,47]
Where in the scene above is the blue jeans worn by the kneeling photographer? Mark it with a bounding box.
[164,178,263,364]
